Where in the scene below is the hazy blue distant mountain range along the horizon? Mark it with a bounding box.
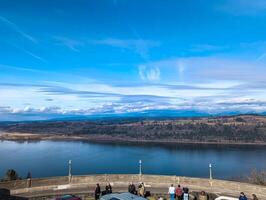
[0,109,266,123]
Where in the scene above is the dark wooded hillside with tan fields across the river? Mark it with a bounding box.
[0,115,266,144]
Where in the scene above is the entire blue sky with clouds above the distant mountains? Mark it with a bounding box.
[0,0,266,121]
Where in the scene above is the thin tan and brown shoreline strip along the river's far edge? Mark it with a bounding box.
[0,132,266,146]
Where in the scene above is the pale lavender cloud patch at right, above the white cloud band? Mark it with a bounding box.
[143,56,266,82]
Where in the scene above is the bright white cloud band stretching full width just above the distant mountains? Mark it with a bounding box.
[0,76,266,120]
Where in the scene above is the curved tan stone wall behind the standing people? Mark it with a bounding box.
[0,174,266,200]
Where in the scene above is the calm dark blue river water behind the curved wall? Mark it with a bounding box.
[0,141,266,179]
